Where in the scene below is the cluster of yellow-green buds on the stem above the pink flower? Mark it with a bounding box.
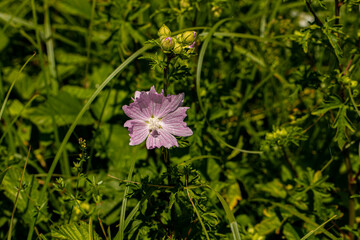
[158,24,197,54]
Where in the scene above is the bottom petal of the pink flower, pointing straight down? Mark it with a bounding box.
[146,129,179,149]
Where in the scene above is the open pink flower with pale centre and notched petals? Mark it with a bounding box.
[123,86,193,149]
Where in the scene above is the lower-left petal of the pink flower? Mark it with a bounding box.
[124,120,149,146]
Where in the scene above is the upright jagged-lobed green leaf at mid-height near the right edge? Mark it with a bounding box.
[333,105,355,150]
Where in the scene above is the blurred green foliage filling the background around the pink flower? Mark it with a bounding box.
[0,0,360,239]
